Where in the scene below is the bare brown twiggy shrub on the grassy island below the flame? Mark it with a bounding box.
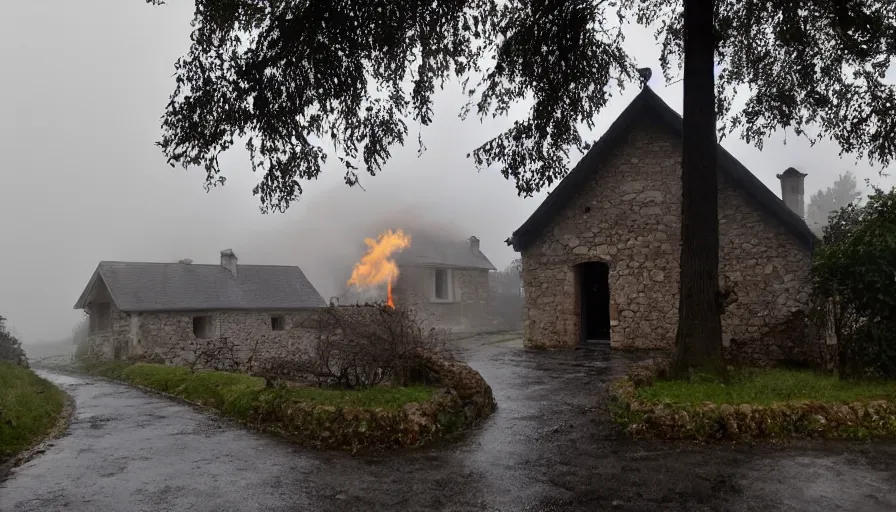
[252,305,448,389]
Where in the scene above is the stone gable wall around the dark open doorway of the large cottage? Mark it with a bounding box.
[522,119,811,360]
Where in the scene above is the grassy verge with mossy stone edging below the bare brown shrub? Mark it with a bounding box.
[83,363,468,451]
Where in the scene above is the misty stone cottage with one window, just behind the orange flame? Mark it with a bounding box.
[393,234,495,330]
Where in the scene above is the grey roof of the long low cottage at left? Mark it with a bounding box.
[75,261,326,312]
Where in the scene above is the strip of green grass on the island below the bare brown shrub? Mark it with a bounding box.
[85,363,435,410]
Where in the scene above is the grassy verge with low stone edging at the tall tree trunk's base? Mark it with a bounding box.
[611,365,896,441]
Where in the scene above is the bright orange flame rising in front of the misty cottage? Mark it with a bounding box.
[348,229,411,308]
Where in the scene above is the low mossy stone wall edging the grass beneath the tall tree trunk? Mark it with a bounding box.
[610,360,896,441]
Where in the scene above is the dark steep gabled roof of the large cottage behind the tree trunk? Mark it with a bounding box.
[507,87,817,251]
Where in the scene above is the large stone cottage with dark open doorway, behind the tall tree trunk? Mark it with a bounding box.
[507,87,817,360]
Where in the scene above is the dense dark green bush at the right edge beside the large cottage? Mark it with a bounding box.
[812,188,896,378]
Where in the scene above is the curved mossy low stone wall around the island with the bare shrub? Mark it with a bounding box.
[85,355,497,453]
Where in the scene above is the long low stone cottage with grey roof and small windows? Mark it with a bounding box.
[75,249,326,362]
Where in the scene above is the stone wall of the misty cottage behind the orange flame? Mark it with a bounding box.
[393,267,497,331]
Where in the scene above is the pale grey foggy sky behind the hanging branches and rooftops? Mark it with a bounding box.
[0,0,894,342]
